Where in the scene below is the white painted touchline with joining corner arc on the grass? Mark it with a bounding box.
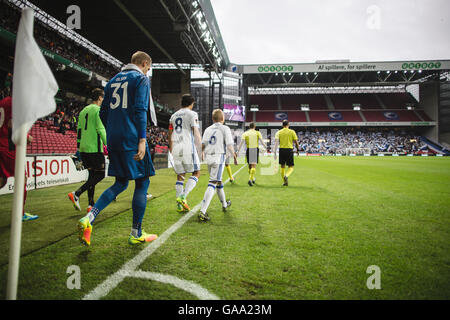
[83,164,246,300]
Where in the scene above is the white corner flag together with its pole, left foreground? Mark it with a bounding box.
[6,8,58,300]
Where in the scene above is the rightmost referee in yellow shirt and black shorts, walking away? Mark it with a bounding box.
[273,120,300,186]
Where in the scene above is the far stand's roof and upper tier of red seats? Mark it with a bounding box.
[237,60,450,154]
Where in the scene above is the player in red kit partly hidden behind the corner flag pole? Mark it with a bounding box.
[0,96,39,221]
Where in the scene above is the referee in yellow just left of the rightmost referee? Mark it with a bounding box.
[236,122,267,187]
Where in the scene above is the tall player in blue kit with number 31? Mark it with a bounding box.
[78,51,158,245]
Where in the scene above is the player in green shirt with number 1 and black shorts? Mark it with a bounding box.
[68,88,106,212]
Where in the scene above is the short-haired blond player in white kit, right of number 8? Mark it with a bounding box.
[198,109,237,221]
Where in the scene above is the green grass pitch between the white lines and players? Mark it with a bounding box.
[0,157,450,300]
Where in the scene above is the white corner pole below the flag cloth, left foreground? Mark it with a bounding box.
[6,124,27,300]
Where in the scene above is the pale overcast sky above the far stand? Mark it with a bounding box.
[211,0,450,64]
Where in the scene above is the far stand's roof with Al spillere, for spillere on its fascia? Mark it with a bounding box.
[236,60,450,88]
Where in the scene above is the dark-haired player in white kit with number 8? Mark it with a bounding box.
[169,94,202,212]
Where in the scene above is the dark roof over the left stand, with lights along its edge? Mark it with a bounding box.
[26,0,229,72]
